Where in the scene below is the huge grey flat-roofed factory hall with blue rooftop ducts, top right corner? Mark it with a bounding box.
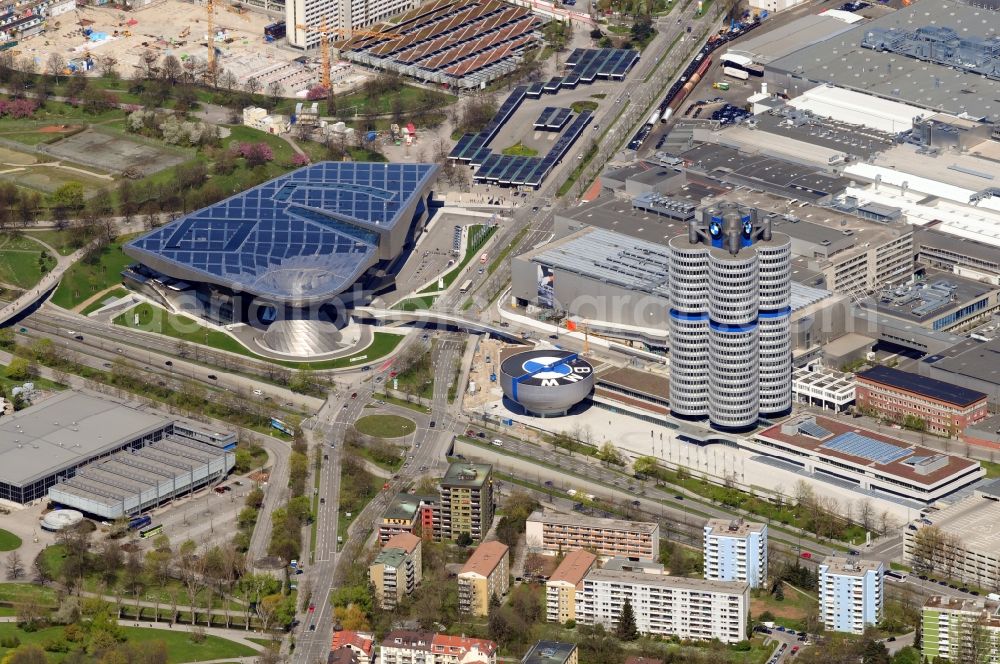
[764,0,1000,123]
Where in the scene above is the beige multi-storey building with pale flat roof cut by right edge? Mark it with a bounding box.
[903,480,1000,588]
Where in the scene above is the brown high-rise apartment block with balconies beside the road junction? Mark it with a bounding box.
[439,462,496,541]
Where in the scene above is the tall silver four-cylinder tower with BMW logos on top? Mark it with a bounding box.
[669,203,792,431]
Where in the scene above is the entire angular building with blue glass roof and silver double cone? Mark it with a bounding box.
[124,162,439,356]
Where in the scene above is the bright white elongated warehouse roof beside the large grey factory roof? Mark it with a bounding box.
[788,85,932,134]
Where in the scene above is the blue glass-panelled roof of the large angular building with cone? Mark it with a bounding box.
[125,162,437,300]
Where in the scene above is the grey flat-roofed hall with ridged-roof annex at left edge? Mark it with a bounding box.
[0,391,235,508]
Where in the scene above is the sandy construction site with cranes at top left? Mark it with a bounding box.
[16,0,367,97]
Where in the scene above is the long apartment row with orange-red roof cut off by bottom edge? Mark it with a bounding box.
[379,629,497,664]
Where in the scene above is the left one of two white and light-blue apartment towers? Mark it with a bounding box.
[704,519,767,588]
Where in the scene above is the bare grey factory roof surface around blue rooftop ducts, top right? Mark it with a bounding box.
[765,0,1000,123]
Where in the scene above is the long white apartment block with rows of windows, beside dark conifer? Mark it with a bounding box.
[576,569,750,643]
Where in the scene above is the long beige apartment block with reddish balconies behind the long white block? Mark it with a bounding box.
[525,511,660,560]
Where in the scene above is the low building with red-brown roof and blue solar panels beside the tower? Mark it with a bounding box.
[752,415,986,504]
